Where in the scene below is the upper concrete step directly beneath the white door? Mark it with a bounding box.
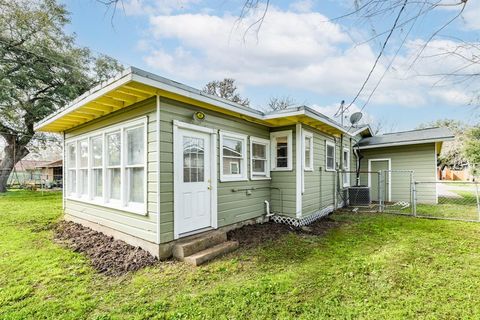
[173,231,227,261]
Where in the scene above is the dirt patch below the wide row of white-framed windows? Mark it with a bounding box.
[54,221,158,276]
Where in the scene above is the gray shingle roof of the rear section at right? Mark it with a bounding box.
[357,128,455,148]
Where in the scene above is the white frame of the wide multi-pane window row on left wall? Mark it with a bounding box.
[65,116,148,215]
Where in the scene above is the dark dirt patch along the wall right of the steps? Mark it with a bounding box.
[227,217,344,247]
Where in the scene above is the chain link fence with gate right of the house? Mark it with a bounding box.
[338,170,480,222]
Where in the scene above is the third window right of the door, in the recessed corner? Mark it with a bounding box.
[270,130,292,171]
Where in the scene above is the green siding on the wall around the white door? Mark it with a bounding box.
[160,98,270,242]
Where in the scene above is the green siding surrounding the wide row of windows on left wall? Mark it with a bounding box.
[65,99,158,242]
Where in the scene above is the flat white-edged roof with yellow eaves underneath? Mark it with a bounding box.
[35,67,351,136]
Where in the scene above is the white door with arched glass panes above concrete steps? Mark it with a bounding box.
[174,128,212,237]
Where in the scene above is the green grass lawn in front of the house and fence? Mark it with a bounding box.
[4,191,480,319]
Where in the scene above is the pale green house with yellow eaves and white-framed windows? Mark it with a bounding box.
[35,68,454,258]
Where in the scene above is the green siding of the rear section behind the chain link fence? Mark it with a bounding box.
[361,143,436,203]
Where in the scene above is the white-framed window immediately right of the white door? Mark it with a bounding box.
[220,132,247,181]
